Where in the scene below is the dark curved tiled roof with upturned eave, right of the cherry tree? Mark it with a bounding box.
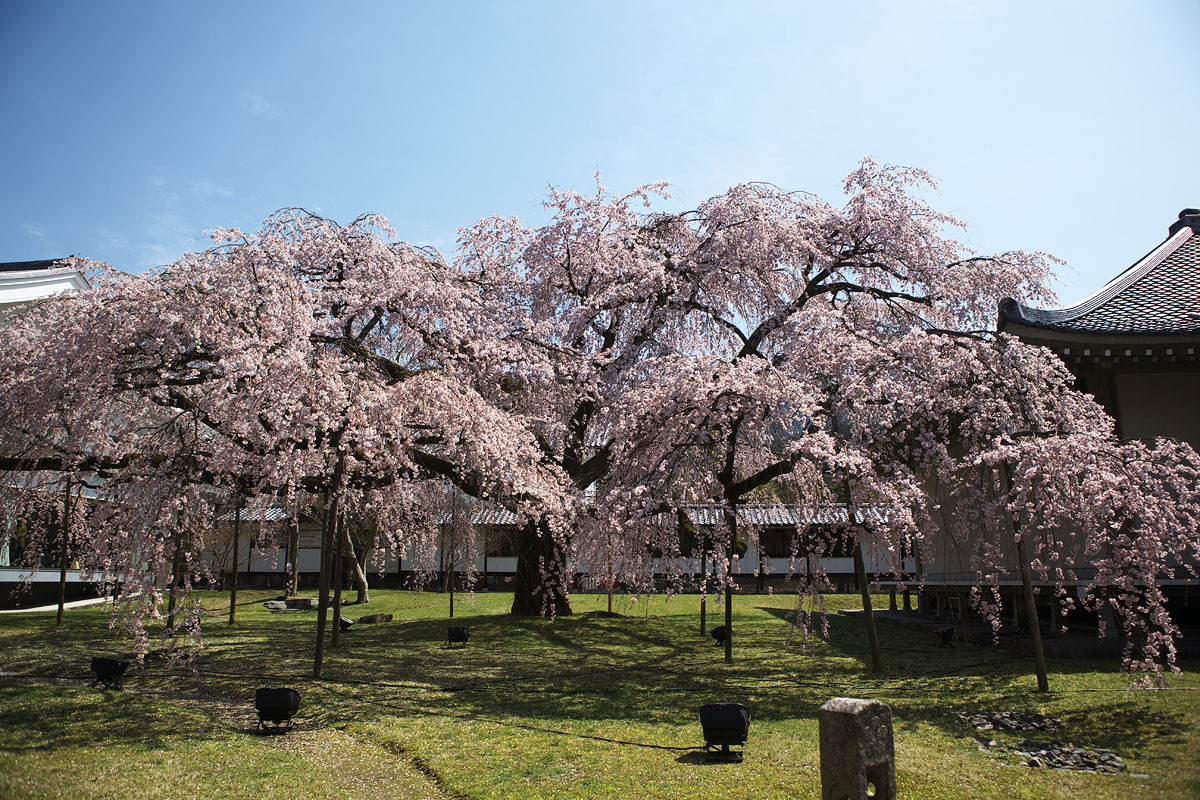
[1000,209,1200,336]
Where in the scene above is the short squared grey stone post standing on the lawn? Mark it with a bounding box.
[817,697,896,800]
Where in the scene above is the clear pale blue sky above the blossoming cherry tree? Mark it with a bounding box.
[0,0,1200,303]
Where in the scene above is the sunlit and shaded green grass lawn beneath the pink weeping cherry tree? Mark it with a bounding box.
[0,591,1200,800]
